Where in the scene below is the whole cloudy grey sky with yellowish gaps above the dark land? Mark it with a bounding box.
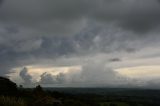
[0,0,160,88]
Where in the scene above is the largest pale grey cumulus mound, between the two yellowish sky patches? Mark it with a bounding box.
[77,62,128,86]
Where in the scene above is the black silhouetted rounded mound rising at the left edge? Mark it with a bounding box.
[0,77,17,95]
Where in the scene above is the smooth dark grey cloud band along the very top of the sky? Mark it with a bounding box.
[0,0,160,32]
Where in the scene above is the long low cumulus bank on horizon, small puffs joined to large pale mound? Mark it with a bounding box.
[39,62,131,87]
